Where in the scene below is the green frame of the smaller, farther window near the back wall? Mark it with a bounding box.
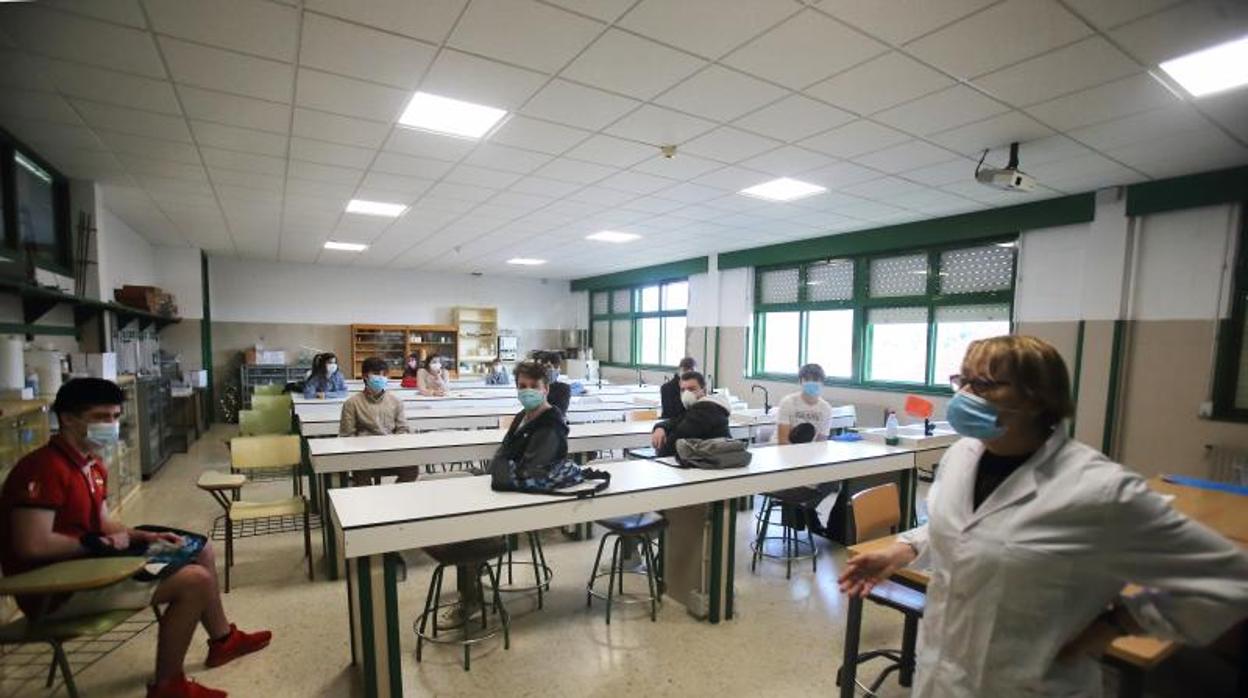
[589,277,689,368]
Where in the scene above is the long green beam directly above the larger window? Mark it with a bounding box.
[718,194,1096,270]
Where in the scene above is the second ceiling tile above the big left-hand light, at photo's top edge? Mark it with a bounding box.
[447,0,604,72]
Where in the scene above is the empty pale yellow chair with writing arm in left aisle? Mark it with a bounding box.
[196,436,313,592]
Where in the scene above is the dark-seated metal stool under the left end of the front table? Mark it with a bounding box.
[412,537,512,672]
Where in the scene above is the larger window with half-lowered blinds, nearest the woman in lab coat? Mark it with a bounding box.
[751,240,1013,392]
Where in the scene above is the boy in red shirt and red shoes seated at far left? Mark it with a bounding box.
[0,378,272,698]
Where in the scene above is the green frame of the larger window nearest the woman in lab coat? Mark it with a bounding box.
[746,233,1018,395]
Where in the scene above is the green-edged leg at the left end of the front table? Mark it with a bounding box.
[347,554,403,698]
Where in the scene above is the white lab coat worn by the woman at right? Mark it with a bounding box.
[902,428,1248,698]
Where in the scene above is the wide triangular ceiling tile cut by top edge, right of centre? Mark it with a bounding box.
[819,0,996,44]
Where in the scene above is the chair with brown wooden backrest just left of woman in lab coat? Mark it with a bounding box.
[836,482,927,696]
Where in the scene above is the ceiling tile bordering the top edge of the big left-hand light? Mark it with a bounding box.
[421,49,547,110]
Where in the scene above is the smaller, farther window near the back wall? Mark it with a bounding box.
[589,280,689,366]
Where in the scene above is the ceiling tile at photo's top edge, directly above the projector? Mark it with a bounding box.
[906,0,1092,77]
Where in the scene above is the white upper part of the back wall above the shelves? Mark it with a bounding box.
[208,257,584,330]
